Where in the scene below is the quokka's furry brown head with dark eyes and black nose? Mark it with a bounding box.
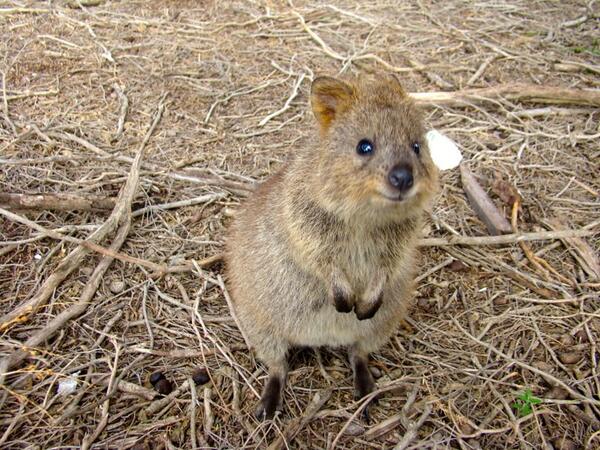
[311,75,438,220]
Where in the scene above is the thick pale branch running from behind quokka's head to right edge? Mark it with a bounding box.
[409,84,600,106]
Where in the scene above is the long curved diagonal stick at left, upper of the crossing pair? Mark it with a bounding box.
[0,95,165,330]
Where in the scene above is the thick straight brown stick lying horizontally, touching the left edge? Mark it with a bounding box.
[0,193,115,211]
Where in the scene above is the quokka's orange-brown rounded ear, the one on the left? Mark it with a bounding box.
[310,77,354,130]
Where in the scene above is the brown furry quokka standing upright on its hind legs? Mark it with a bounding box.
[226,75,438,418]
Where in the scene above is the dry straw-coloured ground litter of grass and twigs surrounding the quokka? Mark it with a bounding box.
[0,0,600,449]
